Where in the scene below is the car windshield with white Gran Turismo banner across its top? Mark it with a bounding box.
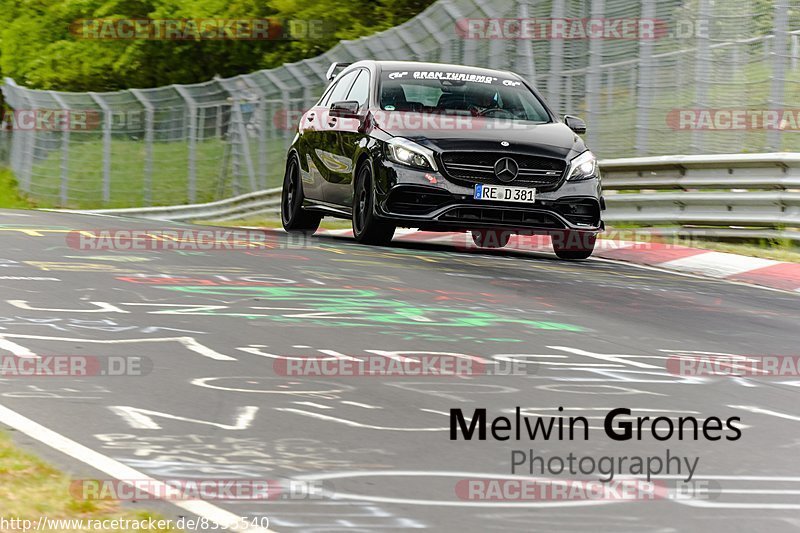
[380,70,551,123]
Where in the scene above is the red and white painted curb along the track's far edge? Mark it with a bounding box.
[310,229,800,292]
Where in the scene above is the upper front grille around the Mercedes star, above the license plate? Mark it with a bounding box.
[441,152,567,190]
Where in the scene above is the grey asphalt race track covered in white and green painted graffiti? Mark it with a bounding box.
[0,211,800,533]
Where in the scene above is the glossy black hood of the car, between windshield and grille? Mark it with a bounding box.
[382,120,586,159]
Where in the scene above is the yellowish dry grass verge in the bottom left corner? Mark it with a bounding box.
[0,431,174,533]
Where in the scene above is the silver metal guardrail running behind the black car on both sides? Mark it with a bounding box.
[64,153,800,241]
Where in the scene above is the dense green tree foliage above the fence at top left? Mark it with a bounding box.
[0,0,433,91]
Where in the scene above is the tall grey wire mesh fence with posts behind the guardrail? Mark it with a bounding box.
[0,0,800,207]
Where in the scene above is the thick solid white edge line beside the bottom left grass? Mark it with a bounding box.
[0,405,275,533]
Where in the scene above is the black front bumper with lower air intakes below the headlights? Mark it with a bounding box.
[376,163,603,233]
